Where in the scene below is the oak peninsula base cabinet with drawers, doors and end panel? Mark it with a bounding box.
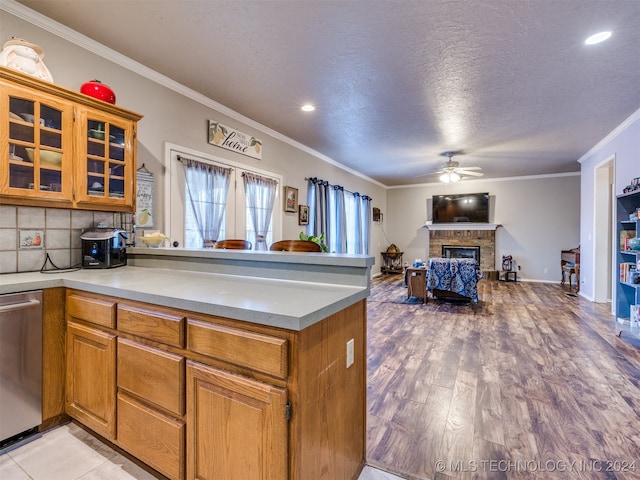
[65,289,366,480]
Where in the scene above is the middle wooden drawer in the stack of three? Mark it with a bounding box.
[118,338,184,416]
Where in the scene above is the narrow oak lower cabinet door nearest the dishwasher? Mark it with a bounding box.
[66,322,116,440]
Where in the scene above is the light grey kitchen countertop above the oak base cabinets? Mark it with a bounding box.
[0,266,369,330]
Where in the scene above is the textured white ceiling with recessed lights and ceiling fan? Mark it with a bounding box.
[11,0,640,186]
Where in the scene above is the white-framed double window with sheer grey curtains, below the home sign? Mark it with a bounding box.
[165,144,282,249]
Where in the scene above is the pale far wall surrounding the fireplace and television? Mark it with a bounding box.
[383,174,580,282]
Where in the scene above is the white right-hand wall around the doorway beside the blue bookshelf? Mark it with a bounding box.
[580,110,640,305]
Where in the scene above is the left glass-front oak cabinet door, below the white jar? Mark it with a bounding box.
[0,87,73,206]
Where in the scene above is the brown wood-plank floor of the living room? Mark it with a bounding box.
[367,275,640,479]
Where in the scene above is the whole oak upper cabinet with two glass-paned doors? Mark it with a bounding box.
[0,67,142,211]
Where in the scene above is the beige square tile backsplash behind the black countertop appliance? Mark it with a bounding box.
[0,205,131,274]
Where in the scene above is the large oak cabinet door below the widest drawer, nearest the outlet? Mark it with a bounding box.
[187,361,287,480]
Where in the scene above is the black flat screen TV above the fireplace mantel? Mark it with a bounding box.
[431,193,489,223]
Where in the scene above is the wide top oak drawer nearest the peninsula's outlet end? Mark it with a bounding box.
[187,319,287,378]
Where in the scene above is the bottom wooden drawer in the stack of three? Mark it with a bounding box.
[118,393,185,480]
